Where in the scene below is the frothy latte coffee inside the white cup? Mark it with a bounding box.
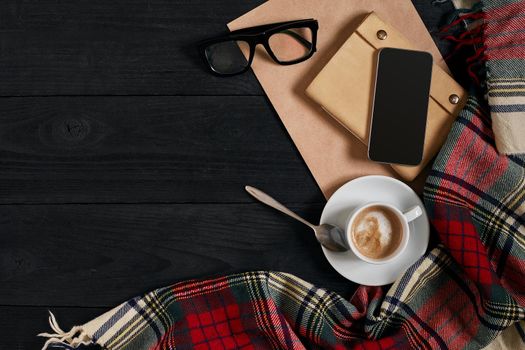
[350,205,403,259]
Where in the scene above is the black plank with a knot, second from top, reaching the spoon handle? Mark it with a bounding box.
[0,97,324,204]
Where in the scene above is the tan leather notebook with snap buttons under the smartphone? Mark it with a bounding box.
[306,13,467,181]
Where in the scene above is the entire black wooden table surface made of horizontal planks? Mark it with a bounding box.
[0,0,452,349]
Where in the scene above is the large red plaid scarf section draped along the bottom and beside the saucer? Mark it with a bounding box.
[42,0,525,350]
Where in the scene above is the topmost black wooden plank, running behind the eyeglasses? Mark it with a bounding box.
[0,0,451,96]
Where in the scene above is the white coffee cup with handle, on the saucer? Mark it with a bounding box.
[345,202,423,264]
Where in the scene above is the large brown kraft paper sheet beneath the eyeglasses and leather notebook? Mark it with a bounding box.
[228,0,464,198]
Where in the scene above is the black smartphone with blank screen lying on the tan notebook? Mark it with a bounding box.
[368,48,432,165]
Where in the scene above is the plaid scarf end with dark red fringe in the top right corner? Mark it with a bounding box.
[448,0,525,154]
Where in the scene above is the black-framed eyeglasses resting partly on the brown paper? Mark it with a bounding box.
[199,19,319,76]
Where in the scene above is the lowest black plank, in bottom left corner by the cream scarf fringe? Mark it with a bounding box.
[0,306,108,350]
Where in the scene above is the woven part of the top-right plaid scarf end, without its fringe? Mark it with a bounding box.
[482,0,525,154]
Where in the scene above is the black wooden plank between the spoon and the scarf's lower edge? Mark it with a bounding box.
[0,203,354,307]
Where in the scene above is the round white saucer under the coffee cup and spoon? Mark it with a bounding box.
[321,175,429,286]
